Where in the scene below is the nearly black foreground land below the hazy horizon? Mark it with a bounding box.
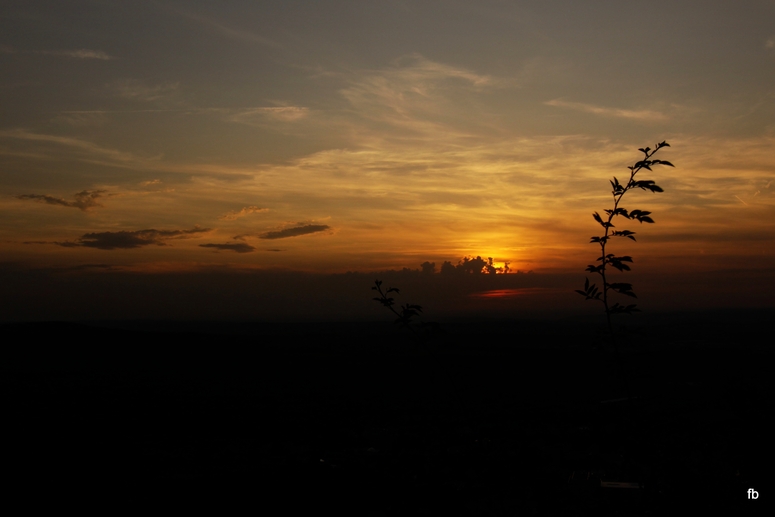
[0,312,775,515]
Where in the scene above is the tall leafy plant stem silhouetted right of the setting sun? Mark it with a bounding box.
[576,142,673,348]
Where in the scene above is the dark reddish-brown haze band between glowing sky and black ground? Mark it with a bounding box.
[0,258,775,322]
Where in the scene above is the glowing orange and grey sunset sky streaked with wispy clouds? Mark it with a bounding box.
[0,0,775,320]
